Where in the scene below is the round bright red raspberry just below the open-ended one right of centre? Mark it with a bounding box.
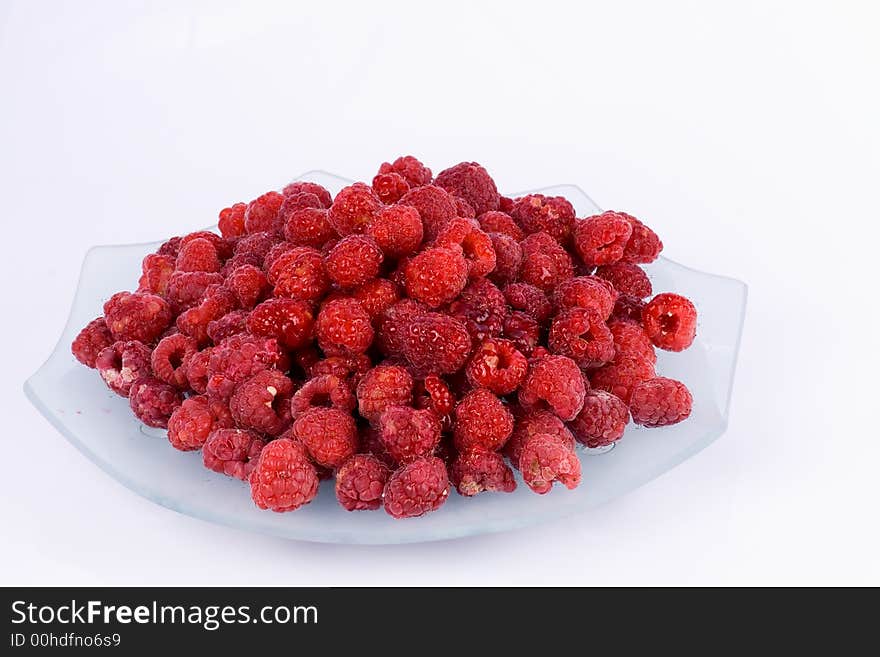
[453,388,513,451]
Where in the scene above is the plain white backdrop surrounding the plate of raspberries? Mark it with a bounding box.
[0,0,880,585]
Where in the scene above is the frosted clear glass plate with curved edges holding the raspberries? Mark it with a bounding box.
[24,171,746,544]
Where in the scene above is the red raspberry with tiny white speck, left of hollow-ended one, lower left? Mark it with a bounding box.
[229,370,293,436]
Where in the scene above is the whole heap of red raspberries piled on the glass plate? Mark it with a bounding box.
[73,156,696,518]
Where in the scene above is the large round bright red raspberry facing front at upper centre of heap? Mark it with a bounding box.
[405,247,468,308]
